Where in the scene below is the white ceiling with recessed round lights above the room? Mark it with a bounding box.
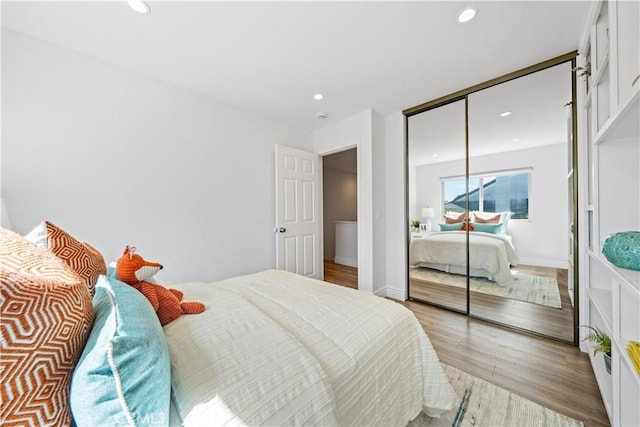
[1,0,589,130]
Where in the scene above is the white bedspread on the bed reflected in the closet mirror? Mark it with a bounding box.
[409,231,520,285]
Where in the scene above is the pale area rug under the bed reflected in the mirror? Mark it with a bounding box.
[409,267,562,308]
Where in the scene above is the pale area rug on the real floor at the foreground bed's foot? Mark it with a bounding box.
[407,363,583,427]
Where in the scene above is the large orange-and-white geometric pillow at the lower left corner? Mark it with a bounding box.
[0,228,93,425]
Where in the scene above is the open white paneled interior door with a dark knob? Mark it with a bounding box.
[275,145,322,279]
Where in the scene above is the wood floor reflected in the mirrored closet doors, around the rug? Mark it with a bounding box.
[409,265,573,342]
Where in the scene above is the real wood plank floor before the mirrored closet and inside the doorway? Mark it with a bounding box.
[325,262,610,427]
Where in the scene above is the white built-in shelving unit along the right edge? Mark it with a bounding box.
[578,0,640,426]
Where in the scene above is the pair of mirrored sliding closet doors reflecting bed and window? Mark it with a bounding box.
[407,62,574,342]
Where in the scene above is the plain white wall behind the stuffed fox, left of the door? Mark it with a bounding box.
[1,30,312,284]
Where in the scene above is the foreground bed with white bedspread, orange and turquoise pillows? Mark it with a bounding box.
[0,225,456,426]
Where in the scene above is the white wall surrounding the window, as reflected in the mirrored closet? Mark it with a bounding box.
[410,144,569,268]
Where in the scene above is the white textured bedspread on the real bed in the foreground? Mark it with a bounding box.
[164,270,455,426]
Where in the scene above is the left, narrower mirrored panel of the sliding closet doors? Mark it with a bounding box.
[407,99,467,312]
